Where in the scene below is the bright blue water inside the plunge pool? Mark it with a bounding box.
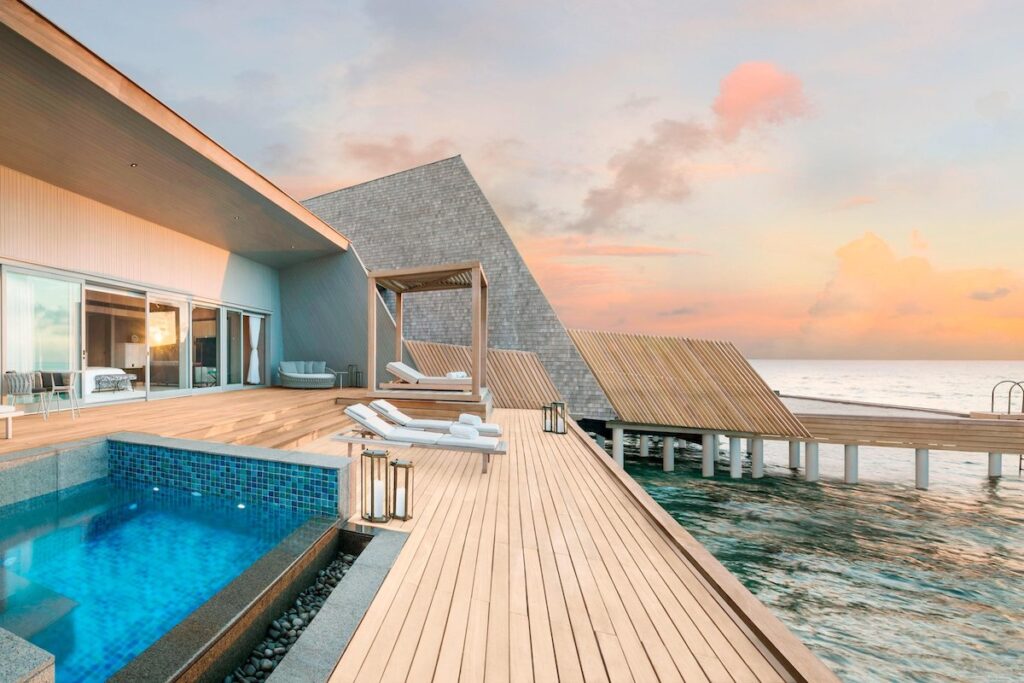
[0,479,305,683]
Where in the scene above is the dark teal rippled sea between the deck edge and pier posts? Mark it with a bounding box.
[614,442,1024,681]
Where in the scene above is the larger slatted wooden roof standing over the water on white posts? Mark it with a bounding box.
[569,330,810,438]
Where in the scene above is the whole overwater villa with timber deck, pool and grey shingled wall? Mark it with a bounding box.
[8,0,1015,682]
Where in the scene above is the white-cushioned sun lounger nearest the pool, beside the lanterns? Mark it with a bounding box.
[333,403,508,473]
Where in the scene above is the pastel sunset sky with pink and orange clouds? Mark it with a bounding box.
[32,0,1024,358]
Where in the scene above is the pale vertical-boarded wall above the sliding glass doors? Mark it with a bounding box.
[0,166,281,309]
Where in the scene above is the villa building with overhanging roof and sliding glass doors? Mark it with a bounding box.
[0,2,399,402]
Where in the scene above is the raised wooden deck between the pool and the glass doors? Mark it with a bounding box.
[0,388,366,455]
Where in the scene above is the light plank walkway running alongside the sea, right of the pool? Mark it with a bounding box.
[303,410,835,683]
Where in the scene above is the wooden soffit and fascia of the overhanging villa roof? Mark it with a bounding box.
[0,0,348,267]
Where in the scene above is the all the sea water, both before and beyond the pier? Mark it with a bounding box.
[627,360,1024,682]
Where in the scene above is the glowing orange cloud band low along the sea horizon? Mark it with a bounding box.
[522,228,1024,358]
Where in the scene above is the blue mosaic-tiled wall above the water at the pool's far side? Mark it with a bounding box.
[108,440,338,517]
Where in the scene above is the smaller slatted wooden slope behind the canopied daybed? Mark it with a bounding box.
[406,340,561,410]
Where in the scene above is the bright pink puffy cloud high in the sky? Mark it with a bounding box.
[712,61,808,141]
